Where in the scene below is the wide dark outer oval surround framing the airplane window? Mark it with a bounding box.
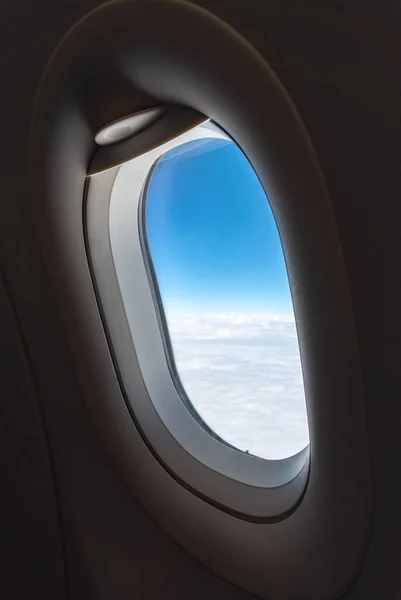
[30,0,371,600]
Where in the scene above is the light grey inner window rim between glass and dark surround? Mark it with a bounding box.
[86,118,309,520]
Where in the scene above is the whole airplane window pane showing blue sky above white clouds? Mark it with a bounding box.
[143,138,309,459]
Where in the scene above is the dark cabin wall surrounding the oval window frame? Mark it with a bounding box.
[0,0,401,600]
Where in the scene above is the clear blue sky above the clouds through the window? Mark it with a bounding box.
[146,139,292,313]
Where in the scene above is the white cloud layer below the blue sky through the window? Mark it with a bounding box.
[167,313,309,459]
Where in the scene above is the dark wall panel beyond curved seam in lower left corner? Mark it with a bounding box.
[0,271,65,600]
